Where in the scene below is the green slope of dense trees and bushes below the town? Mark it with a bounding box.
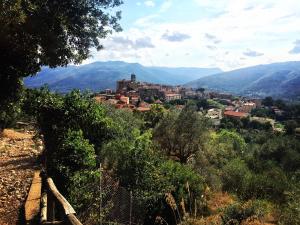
[15,89,300,224]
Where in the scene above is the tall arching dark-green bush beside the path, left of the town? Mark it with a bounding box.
[39,91,118,157]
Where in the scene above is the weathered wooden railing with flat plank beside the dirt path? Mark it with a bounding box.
[25,173,82,225]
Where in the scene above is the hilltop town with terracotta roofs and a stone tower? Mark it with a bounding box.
[94,74,284,131]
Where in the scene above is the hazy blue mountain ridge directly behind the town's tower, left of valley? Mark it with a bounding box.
[24,61,222,92]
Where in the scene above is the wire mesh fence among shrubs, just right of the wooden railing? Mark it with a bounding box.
[76,164,144,225]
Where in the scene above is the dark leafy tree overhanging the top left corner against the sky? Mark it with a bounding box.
[0,0,122,126]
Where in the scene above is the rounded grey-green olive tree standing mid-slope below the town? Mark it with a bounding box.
[153,105,208,163]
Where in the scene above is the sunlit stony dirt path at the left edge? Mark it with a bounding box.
[0,130,42,225]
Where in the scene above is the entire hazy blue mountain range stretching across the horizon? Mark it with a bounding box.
[24,61,300,99]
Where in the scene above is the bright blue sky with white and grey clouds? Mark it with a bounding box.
[85,0,300,70]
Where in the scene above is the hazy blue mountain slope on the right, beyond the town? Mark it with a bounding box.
[185,62,300,98]
